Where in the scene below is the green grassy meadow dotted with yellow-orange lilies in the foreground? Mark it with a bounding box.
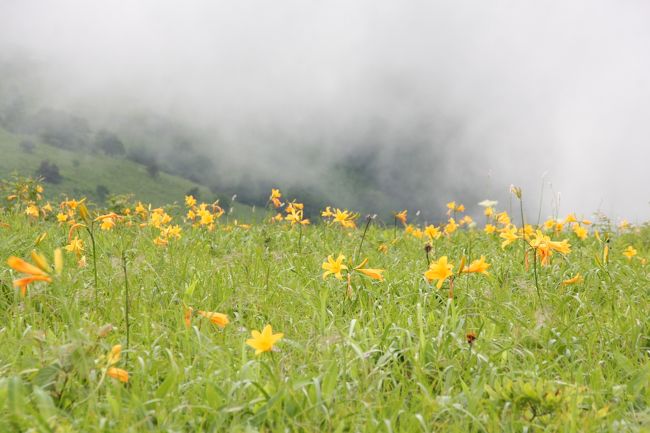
[0,180,650,432]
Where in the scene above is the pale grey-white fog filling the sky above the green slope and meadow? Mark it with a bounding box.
[0,0,650,221]
